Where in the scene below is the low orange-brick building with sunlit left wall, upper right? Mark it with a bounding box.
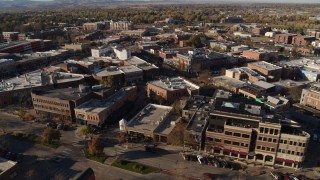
[242,49,278,61]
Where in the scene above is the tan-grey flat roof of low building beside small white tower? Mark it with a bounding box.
[127,104,172,132]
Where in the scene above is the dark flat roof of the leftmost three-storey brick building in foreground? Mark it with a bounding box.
[33,88,88,101]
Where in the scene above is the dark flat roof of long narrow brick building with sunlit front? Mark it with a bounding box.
[75,87,135,113]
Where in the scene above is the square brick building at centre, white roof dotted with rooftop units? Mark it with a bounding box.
[147,77,200,103]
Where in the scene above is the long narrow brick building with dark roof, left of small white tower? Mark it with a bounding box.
[74,86,137,126]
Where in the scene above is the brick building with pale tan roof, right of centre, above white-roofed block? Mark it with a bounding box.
[248,61,282,81]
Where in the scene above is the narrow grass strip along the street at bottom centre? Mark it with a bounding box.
[112,160,160,174]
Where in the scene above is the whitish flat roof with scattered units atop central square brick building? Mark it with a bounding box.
[148,77,200,91]
